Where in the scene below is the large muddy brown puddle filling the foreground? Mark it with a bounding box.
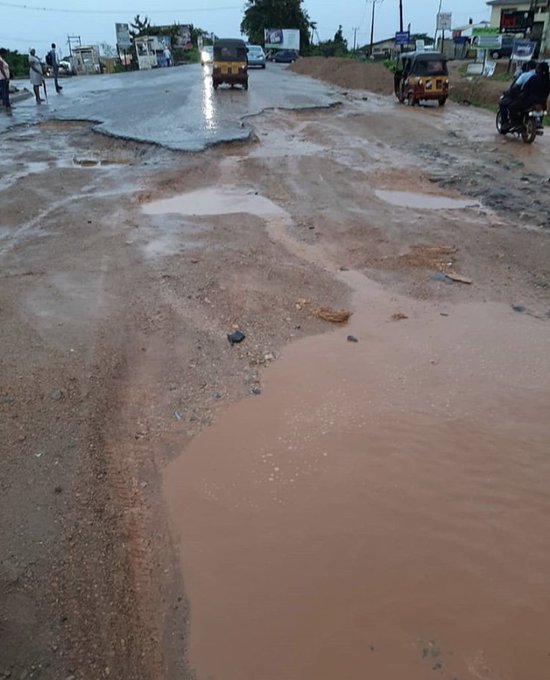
[165,272,550,680]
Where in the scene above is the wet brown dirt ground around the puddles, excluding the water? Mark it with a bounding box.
[0,78,550,680]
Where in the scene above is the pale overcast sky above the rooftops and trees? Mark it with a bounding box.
[0,0,489,55]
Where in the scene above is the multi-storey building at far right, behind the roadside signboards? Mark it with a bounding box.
[487,0,550,56]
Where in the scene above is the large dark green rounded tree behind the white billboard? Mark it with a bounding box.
[241,0,311,48]
